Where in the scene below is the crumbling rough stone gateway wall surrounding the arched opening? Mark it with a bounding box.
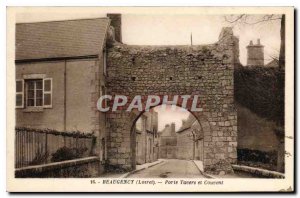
[106,28,238,170]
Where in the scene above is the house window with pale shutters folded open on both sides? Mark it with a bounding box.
[16,78,52,108]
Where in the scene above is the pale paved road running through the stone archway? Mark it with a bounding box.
[129,159,204,178]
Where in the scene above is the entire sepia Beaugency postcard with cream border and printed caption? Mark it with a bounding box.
[7,7,295,192]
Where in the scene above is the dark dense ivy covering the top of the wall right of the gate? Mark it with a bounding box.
[234,66,285,126]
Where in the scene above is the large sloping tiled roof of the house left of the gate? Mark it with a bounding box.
[16,18,109,60]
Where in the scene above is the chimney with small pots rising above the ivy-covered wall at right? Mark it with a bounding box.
[247,39,264,66]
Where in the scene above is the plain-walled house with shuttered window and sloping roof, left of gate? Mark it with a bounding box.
[15,18,109,171]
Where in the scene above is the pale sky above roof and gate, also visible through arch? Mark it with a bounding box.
[16,8,280,130]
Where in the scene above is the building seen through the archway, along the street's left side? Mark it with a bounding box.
[135,110,158,164]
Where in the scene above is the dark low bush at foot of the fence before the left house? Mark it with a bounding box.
[51,146,88,162]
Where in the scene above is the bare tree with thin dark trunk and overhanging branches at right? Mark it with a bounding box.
[225,14,285,172]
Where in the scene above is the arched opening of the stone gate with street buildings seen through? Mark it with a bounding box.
[131,105,204,172]
